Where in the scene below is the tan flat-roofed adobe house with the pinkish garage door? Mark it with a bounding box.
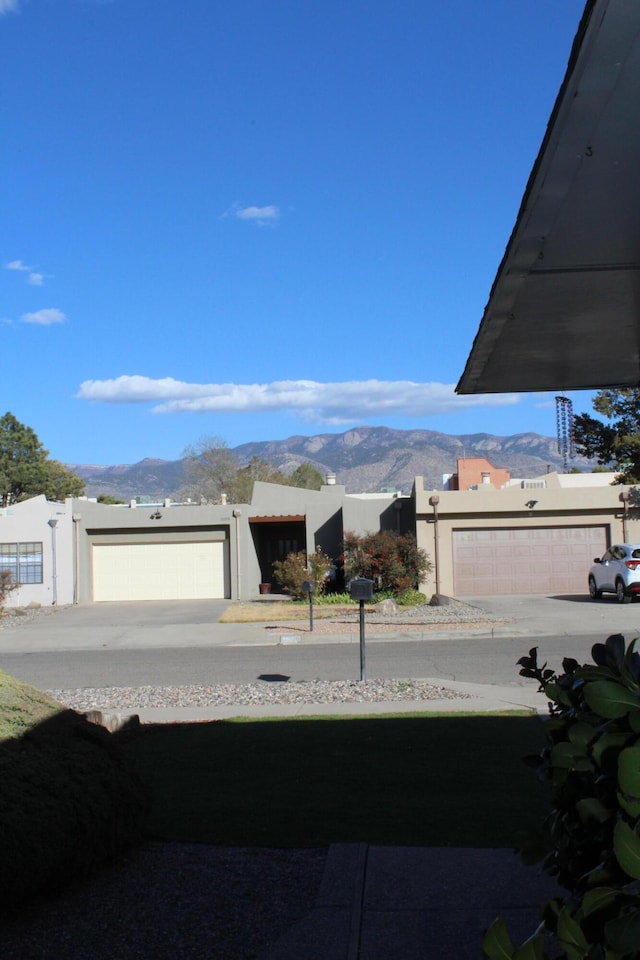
[413,473,640,597]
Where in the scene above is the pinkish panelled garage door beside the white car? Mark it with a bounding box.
[453,526,608,597]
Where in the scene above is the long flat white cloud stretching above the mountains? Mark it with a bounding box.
[77,376,519,424]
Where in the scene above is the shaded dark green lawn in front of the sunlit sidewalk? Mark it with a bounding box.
[126,714,546,847]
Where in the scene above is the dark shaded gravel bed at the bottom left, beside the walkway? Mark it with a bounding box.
[0,842,326,960]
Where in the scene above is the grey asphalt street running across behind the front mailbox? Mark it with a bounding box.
[0,634,604,689]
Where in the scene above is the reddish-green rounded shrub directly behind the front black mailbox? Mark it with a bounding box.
[343,530,431,596]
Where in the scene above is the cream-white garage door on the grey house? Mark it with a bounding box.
[92,541,229,600]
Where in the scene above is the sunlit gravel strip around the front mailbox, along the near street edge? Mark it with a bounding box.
[45,680,468,712]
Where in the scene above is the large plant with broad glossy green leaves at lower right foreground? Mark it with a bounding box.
[483,634,640,960]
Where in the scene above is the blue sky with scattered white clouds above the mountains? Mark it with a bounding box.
[0,0,591,464]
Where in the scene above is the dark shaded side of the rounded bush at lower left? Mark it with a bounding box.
[0,711,147,911]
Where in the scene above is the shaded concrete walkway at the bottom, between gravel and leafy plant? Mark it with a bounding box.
[257,844,562,960]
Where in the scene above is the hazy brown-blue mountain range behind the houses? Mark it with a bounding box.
[67,427,593,500]
